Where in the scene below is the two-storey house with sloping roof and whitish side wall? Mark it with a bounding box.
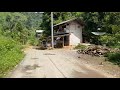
[49,19,84,47]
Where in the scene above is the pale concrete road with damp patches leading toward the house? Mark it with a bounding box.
[8,49,114,78]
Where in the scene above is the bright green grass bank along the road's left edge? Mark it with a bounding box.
[0,36,24,77]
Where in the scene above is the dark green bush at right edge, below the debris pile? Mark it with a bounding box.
[105,52,120,65]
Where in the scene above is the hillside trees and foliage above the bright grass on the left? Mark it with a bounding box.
[0,12,42,44]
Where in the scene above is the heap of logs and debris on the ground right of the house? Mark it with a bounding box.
[77,45,120,56]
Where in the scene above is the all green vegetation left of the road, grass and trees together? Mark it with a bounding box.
[0,12,42,77]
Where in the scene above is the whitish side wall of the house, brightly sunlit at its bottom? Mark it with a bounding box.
[69,22,82,45]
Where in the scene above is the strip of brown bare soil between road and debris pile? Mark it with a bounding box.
[80,54,120,78]
